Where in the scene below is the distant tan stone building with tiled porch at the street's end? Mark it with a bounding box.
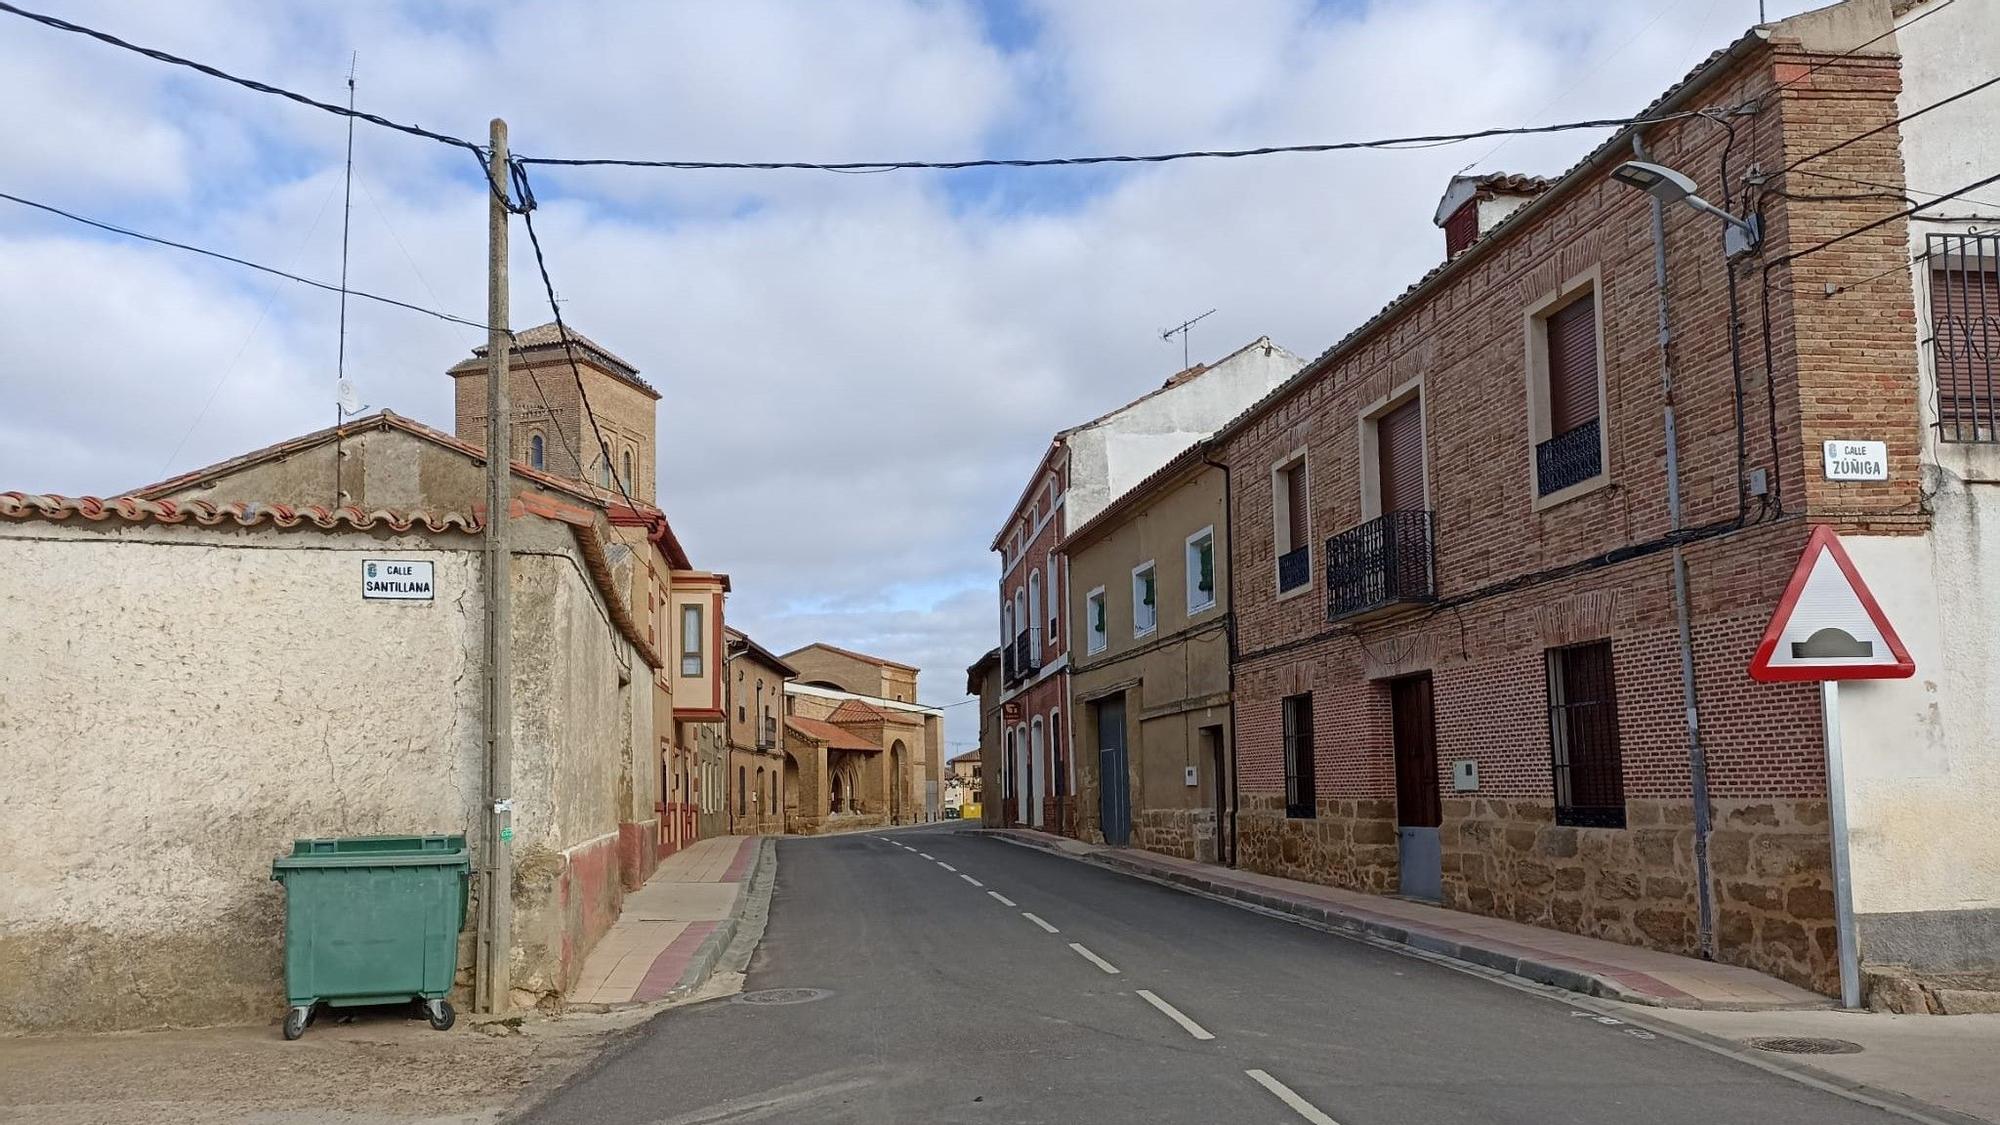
[782,643,944,835]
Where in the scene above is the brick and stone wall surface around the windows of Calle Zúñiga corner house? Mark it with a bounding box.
[1220,44,1922,989]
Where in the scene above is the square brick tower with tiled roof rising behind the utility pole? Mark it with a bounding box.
[448,324,660,504]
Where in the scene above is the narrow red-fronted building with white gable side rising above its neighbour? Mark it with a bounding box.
[980,338,1304,831]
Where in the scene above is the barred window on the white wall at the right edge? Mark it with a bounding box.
[1924,234,2000,442]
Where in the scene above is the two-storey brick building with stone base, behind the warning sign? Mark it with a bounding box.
[1212,0,1994,991]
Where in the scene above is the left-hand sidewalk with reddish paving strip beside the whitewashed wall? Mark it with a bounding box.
[568,837,770,1007]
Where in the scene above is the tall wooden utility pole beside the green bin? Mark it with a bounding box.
[472,118,514,1011]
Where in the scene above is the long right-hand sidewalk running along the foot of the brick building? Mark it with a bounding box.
[980,829,1832,1011]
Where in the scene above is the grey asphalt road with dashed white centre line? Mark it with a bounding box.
[526,829,1902,1125]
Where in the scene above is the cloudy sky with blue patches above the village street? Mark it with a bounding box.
[0,0,1808,753]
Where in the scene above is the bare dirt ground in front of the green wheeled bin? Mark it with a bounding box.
[0,973,742,1125]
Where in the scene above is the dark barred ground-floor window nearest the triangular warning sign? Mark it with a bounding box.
[1548,641,1624,829]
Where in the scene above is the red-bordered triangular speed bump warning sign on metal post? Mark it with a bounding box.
[1750,524,1916,681]
